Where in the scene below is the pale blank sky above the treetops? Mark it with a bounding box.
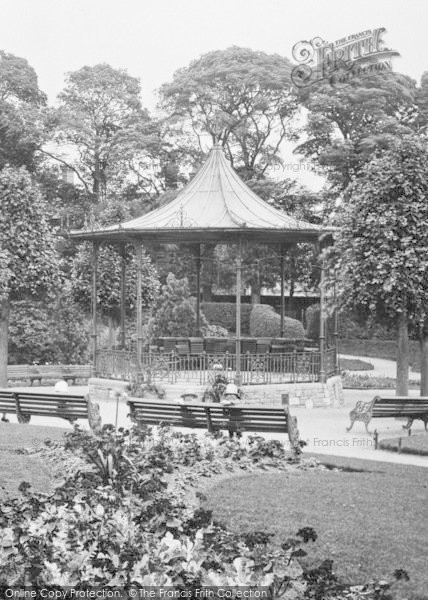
[0,0,428,189]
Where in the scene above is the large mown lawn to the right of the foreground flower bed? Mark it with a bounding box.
[207,456,428,600]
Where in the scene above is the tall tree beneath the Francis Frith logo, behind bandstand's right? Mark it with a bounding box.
[296,72,416,194]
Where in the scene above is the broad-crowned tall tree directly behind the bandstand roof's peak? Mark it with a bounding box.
[160,46,297,179]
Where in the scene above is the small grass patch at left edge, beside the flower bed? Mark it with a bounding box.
[0,423,64,500]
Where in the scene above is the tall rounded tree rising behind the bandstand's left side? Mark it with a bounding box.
[49,64,149,203]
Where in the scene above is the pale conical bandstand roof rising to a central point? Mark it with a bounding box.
[70,144,327,244]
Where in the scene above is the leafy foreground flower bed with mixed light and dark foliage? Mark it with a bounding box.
[0,426,412,600]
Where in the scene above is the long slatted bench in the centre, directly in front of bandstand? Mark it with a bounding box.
[128,398,299,447]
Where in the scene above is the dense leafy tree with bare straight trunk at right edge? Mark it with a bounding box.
[331,134,428,395]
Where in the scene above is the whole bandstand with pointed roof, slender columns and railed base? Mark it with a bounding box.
[70,144,337,385]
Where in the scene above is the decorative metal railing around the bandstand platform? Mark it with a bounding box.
[96,349,336,385]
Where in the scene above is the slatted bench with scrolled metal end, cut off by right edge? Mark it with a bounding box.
[346,396,428,433]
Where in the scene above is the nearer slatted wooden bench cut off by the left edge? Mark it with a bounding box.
[0,390,101,431]
